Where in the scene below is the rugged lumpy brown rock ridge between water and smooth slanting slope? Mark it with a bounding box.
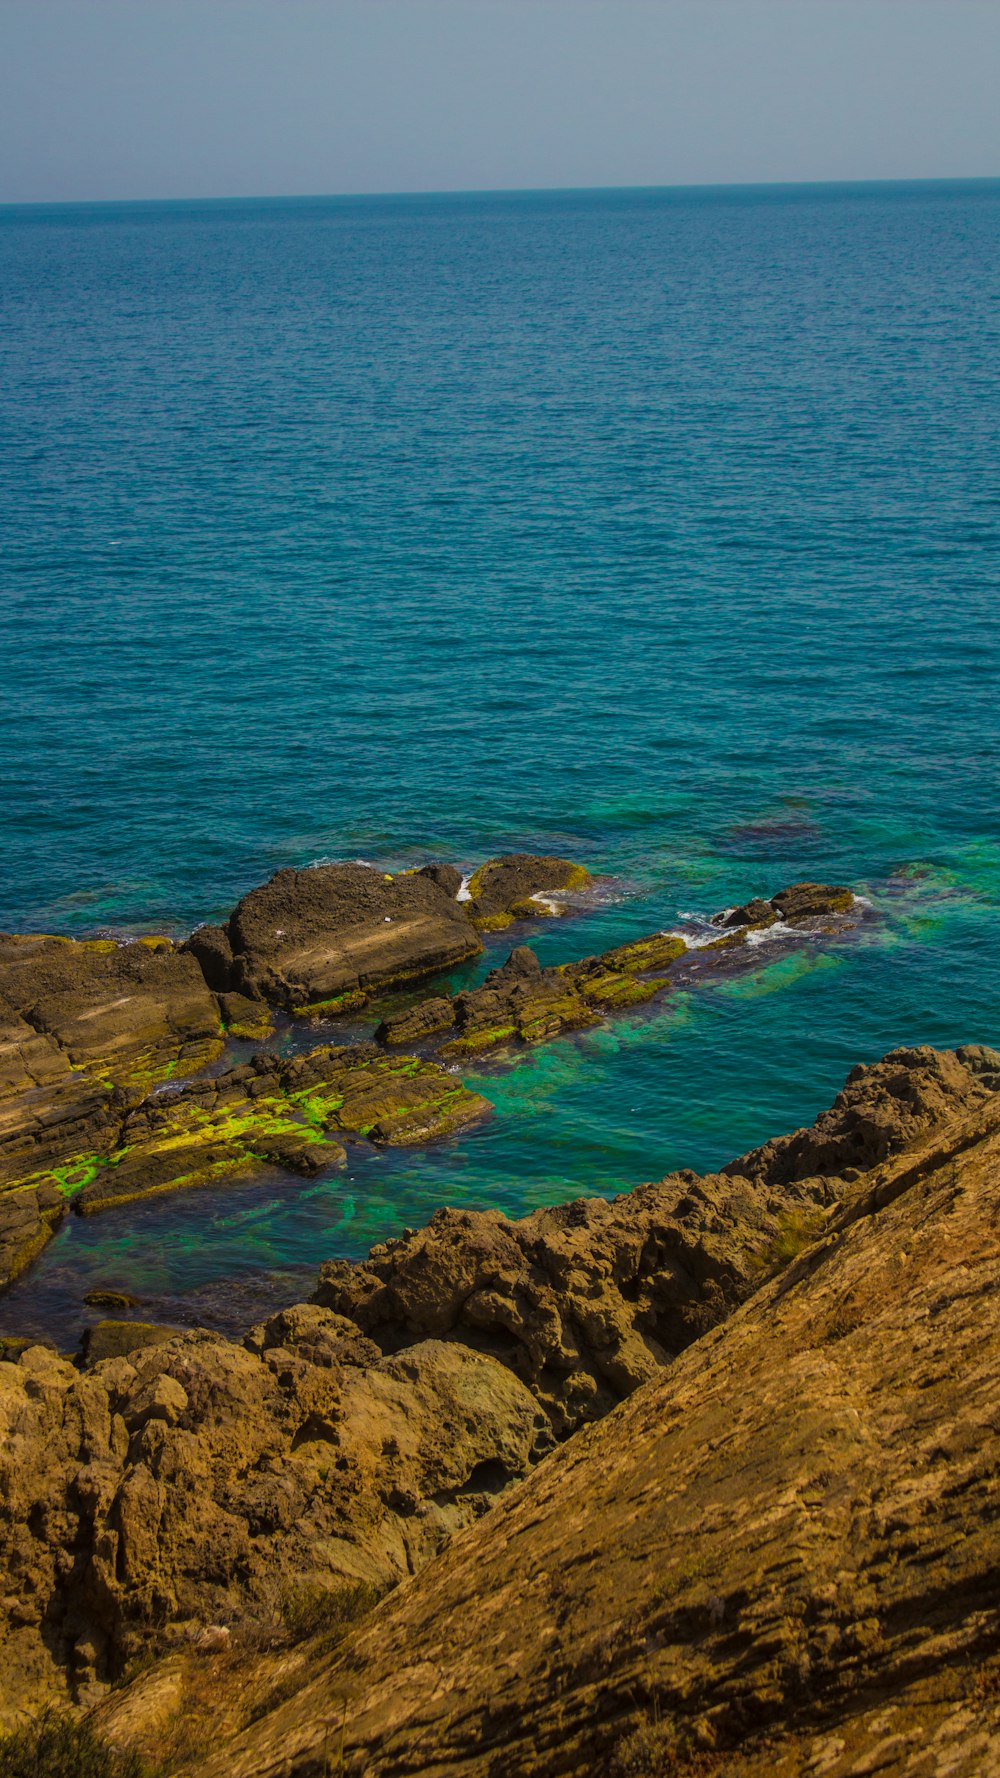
[0,1049,1000,1735]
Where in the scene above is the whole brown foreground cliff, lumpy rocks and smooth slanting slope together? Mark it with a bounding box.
[0,1047,1000,1778]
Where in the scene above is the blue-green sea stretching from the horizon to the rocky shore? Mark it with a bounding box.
[0,181,1000,1339]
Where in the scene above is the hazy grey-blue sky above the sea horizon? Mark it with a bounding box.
[0,0,1000,201]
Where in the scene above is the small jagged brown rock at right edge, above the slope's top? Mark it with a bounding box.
[724,1045,1000,1186]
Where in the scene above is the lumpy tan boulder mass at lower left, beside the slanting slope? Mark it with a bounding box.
[0,1329,550,1716]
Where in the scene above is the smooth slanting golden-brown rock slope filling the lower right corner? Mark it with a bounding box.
[185,1063,1000,1778]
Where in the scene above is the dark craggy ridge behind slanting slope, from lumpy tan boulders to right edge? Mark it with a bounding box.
[315,1045,1000,1438]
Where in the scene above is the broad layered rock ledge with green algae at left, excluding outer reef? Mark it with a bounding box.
[0,855,585,1287]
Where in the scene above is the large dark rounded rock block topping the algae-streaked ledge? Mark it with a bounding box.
[187,864,482,1013]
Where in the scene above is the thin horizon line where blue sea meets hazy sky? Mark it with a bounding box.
[0,172,1000,210]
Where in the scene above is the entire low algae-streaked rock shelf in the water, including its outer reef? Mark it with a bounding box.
[0,855,872,1337]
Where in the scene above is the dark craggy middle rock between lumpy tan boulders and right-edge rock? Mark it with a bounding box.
[315,1173,829,1438]
